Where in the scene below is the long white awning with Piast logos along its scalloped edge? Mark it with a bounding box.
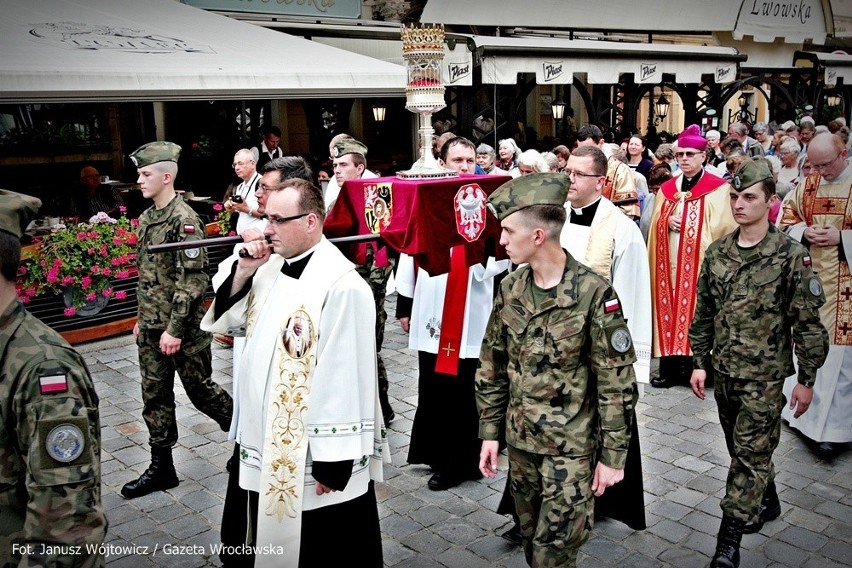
[470,36,745,85]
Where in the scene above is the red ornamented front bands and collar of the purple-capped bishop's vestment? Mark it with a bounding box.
[651,171,727,356]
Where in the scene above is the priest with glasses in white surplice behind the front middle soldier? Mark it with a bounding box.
[559,146,651,388]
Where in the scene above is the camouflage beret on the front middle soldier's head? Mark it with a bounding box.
[488,172,571,221]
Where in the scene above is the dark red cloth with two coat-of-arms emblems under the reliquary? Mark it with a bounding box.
[323,175,512,276]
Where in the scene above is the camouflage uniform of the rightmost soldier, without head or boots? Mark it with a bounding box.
[689,224,828,522]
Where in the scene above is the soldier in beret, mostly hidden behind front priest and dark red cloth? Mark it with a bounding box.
[325,138,399,426]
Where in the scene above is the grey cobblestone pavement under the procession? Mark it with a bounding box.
[78,296,852,568]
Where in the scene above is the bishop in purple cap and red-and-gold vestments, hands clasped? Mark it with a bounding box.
[648,124,736,388]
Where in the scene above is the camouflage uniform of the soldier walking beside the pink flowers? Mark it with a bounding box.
[136,196,233,448]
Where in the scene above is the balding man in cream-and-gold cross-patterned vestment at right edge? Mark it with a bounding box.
[779,133,852,459]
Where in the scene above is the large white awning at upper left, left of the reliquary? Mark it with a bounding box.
[0,0,406,103]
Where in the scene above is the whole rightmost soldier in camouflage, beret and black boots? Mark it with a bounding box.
[689,158,828,568]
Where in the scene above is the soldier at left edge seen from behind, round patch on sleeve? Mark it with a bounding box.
[0,190,107,568]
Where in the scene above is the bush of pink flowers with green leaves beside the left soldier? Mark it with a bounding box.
[17,208,137,317]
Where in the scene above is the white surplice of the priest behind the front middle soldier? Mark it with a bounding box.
[559,197,651,383]
